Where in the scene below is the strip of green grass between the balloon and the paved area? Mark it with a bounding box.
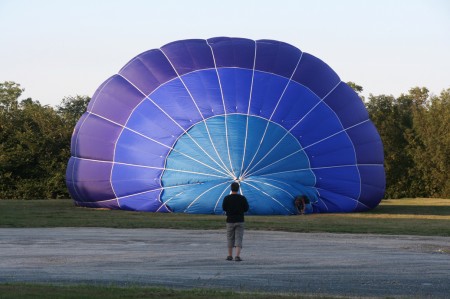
[0,198,450,236]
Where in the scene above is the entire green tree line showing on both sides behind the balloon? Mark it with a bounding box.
[0,81,450,199]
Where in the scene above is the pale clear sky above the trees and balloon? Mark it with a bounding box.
[0,0,450,106]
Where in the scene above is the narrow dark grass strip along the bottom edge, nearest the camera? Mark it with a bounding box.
[0,283,332,299]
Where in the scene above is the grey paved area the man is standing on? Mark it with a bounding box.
[0,228,450,298]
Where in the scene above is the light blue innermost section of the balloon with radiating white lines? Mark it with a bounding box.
[160,113,315,214]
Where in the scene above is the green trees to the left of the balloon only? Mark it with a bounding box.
[0,82,89,199]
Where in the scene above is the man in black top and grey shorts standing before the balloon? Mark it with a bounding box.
[222,182,248,262]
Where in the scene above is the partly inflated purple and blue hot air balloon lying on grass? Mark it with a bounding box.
[66,37,385,215]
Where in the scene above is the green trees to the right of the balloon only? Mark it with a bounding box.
[366,87,450,198]
